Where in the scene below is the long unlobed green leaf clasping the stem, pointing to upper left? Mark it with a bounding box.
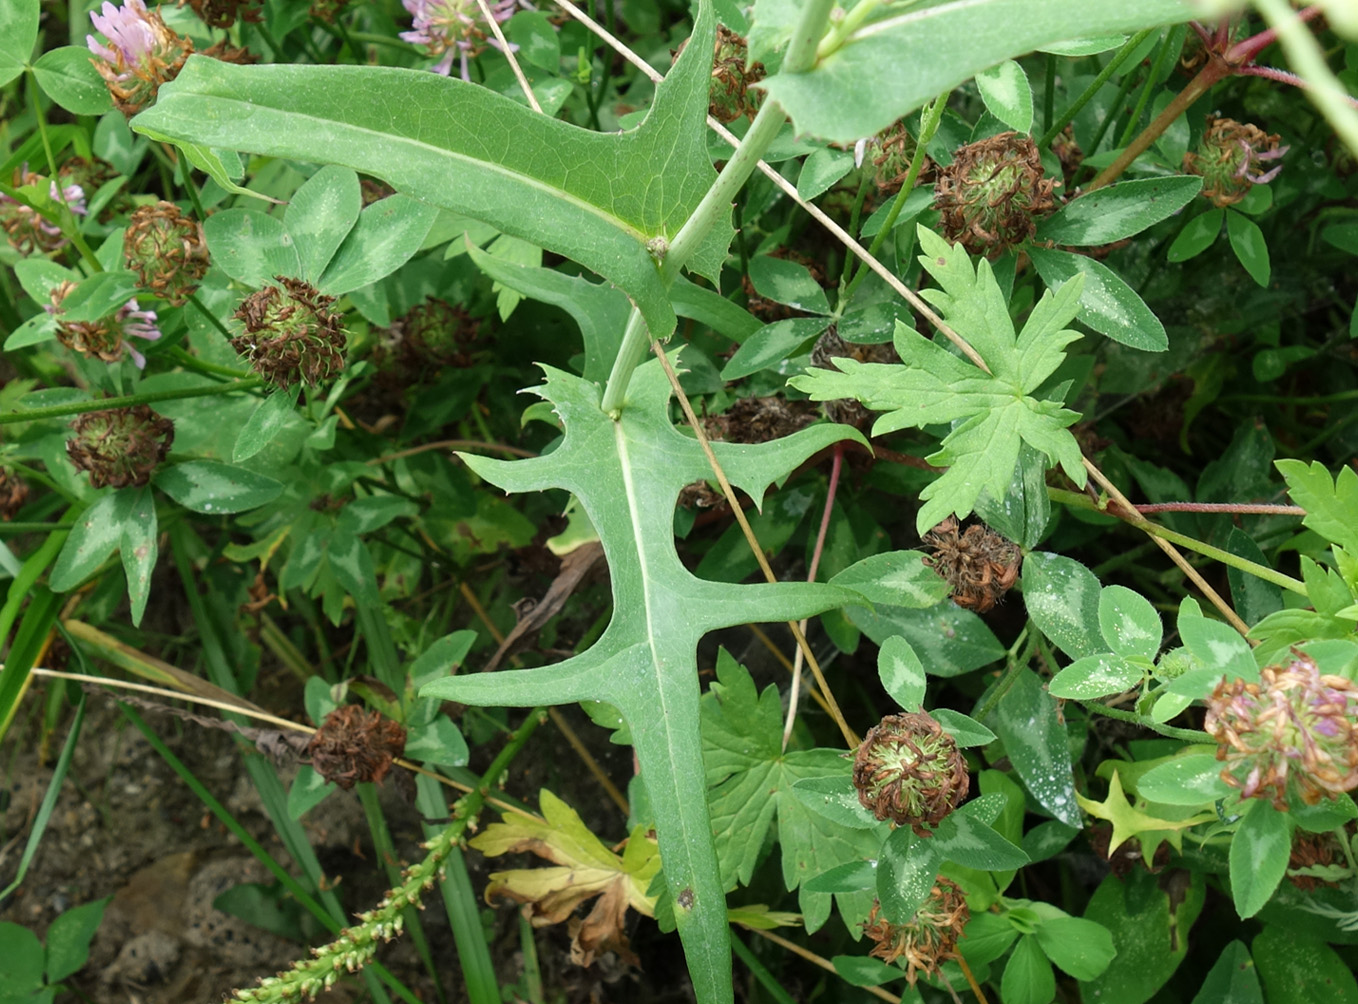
[133,4,735,338]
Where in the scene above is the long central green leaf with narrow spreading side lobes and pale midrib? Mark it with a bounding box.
[421,361,862,1004]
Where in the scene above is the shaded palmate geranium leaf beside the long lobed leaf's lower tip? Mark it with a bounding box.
[702,651,881,931]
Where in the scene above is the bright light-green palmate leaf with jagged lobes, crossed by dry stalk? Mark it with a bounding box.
[792,227,1085,534]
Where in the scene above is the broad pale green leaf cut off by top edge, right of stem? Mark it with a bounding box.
[751,0,1198,143]
